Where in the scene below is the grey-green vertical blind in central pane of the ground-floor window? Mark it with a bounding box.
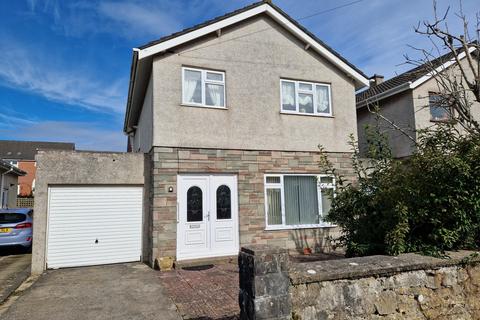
[284,176,319,225]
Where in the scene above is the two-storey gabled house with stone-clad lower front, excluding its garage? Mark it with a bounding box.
[124,1,369,262]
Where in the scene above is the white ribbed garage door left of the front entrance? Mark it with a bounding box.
[47,186,143,268]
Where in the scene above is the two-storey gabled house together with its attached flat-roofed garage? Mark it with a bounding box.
[32,1,369,273]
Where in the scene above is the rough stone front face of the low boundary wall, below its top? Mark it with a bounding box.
[290,266,480,320]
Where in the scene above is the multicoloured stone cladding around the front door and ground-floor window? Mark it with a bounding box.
[148,147,354,264]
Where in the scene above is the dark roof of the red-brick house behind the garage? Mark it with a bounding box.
[0,140,75,160]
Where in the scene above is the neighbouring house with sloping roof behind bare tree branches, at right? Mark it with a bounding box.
[356,47,480,158]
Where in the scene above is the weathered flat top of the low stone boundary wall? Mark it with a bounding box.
[288,247,480,285]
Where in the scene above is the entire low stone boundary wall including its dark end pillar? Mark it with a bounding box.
[239,246,480,320]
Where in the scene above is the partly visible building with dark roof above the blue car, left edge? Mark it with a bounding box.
[0,159,26,208]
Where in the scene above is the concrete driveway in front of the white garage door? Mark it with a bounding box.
[0,263,181,320]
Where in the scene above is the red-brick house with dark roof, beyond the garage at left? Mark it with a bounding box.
[0,140,75,197]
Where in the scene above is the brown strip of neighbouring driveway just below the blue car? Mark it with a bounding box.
[0,254,32,304]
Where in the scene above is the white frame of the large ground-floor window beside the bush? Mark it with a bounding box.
[264,173,336,231]
